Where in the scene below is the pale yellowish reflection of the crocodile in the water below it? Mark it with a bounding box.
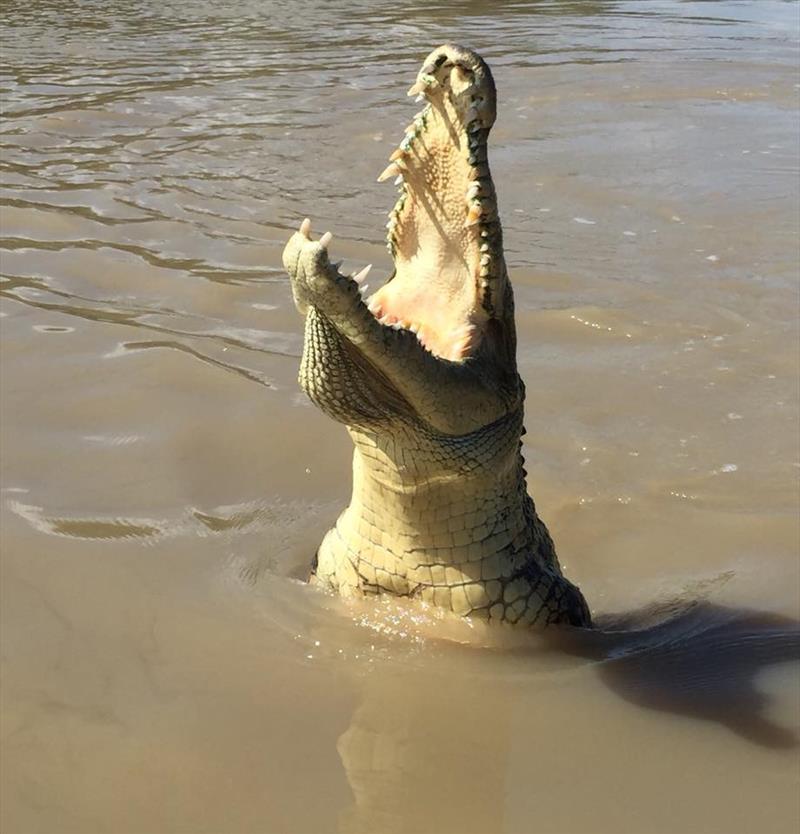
[337,674,511,834]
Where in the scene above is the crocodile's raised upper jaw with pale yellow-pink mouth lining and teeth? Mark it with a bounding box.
[354,45,504,362]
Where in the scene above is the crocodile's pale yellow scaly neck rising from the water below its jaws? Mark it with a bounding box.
[317,409,580,624]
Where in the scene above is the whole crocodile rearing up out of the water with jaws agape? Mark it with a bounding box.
[283,44,591,628]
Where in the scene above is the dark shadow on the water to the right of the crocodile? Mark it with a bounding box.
[548,601,800,749]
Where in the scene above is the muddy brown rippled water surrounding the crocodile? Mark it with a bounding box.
[0,0,800,834]
